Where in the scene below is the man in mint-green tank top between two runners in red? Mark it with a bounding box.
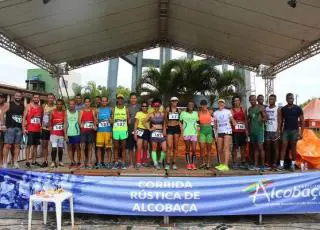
[64,100,81,167]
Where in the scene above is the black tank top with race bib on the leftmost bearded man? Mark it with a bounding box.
[6,101,24,128]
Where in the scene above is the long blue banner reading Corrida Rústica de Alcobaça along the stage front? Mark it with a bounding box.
[0,170,320,216]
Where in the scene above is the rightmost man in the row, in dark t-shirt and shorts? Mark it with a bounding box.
[277,93,304,171]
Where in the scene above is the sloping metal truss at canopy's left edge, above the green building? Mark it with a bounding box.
[0,32,57,74]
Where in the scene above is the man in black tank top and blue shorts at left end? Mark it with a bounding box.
[0,92,24,168]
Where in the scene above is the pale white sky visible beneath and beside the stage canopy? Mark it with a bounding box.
[0,48,320,104]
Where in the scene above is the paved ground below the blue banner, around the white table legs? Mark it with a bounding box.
[0,210,320,230]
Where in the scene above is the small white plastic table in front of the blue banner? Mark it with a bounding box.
[28,192,74,230]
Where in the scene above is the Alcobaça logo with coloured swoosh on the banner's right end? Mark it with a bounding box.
[242,179,320,204]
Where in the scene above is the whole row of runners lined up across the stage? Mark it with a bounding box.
[0,92,304,171]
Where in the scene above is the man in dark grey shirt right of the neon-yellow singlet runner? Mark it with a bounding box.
[127,93,141,168]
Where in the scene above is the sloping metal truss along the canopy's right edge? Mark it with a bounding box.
[263,40,320,76]
